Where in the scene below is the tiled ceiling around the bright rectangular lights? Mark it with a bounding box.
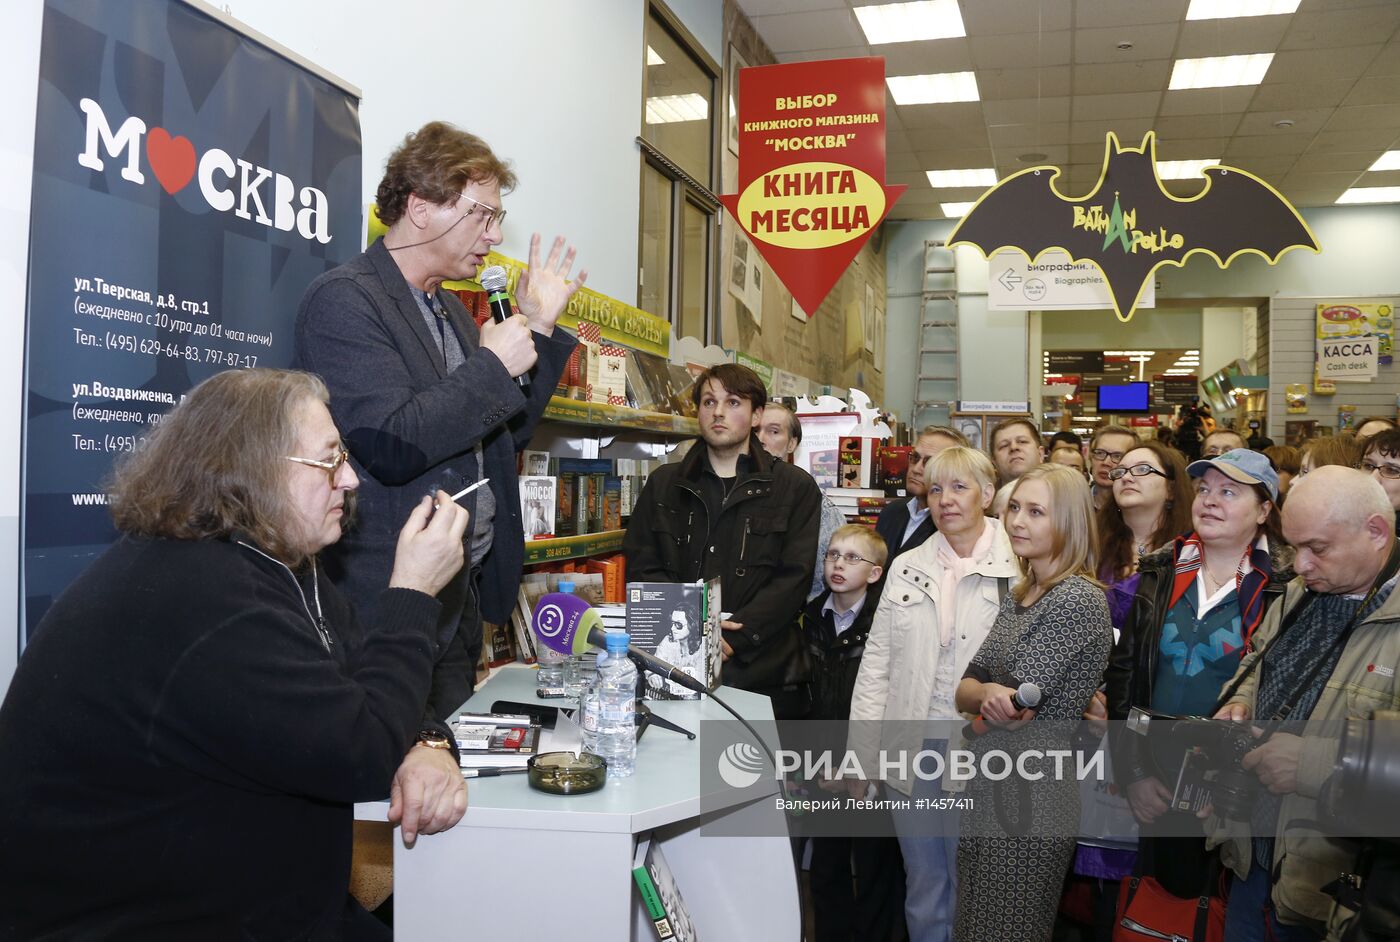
[738,0,1400,218]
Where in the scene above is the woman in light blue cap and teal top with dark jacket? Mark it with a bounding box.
[1105,449,1294,897]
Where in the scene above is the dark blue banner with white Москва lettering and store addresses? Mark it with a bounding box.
[21,0,361,641]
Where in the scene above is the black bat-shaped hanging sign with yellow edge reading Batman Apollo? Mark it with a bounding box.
[948,132,1319,321]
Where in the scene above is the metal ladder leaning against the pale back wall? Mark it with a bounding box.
[910,239,962,425]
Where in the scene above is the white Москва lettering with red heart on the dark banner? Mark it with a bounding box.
[78,98,330,245]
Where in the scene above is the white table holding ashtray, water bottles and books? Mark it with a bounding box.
[356,668,801,942]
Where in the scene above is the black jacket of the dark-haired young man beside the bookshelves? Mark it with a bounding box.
[623,435,822,698]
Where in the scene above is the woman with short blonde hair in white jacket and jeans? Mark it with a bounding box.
[848,447,1021,942]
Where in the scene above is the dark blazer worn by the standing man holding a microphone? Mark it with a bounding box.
[294,239,577,717]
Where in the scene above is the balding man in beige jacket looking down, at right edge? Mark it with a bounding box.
[1207,466,1400,942]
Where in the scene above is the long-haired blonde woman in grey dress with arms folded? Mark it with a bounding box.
[953,465,1113,942]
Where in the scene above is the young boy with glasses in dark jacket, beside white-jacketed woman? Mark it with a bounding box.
[801,523,904,942]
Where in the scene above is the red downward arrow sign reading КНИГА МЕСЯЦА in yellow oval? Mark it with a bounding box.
[720,56,904,318]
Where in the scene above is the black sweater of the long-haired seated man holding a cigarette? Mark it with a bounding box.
[0,537,438,941]
